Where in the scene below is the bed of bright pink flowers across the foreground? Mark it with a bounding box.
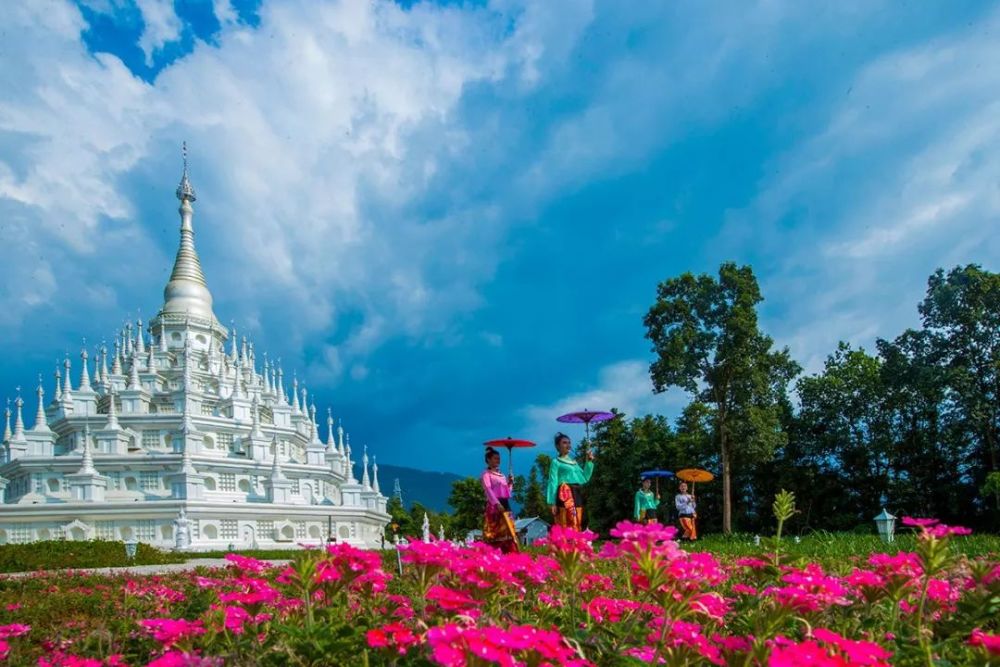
[0,522,1000,667]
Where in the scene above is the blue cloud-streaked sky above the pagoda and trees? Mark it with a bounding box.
[0,0,1000,484]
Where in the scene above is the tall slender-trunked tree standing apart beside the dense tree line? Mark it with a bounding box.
[645,262,799,533]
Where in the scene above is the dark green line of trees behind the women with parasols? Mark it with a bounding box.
[394,262,1000,544]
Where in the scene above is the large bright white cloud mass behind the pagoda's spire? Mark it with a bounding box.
[0,0,585,370]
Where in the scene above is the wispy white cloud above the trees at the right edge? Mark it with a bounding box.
[717,7,1000,372]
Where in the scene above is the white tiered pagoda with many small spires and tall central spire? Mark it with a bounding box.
[0,149,389,550]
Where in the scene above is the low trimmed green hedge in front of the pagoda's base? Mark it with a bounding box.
[0,540,188,572]
